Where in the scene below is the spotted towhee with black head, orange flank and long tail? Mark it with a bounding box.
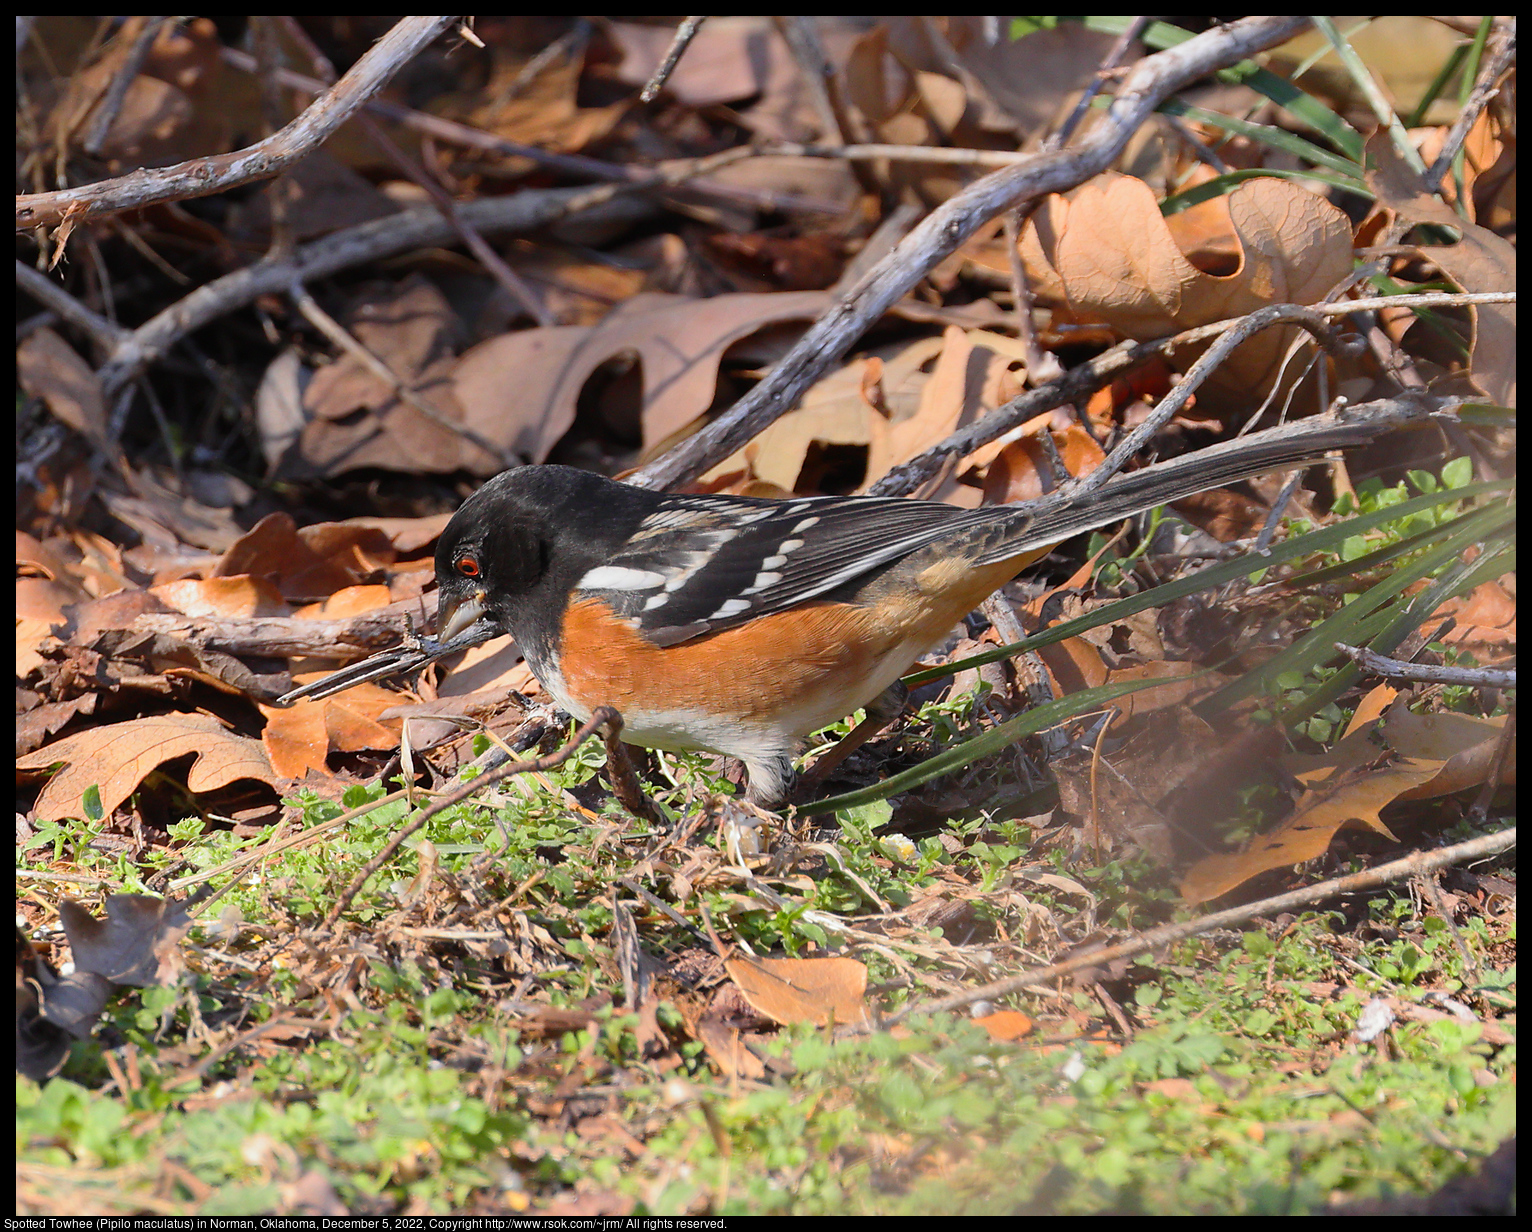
[435,421,1373,809]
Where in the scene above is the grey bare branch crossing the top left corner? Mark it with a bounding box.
[15,15,457,230]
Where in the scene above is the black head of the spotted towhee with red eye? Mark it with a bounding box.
[437,466,657,650]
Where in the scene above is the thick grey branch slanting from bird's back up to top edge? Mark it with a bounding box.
[634,17,1307,487]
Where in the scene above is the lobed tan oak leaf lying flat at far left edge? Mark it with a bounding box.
[17,714,273,821]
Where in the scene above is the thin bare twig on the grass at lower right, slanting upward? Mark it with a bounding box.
[882,826,1517,1027]
